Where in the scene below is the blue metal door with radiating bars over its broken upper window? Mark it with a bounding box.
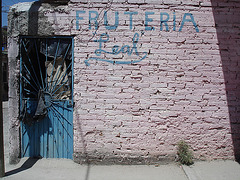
[20,37,73,159]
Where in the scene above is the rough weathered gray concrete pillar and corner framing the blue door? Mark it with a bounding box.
[8,2,54,164]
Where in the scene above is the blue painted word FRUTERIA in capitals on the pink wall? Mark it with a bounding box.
[76,10,199,32]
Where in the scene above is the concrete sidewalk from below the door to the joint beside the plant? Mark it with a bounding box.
[3,158,188,180]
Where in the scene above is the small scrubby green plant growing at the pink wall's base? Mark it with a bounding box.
[177,140,193,166]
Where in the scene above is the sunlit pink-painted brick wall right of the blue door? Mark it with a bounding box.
[45,0,240,161]
